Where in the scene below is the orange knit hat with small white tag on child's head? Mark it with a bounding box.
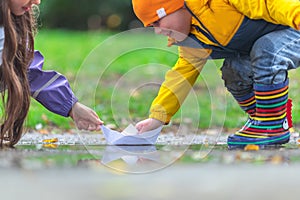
[132,0,184,26]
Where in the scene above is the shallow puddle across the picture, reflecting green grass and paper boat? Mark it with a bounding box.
[0,143,300,170]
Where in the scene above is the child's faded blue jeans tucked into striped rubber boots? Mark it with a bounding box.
[221,28,300,96]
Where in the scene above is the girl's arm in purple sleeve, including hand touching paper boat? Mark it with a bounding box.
[28,51,103,131]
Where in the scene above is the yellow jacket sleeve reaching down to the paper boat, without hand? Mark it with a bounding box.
[149,47,211,123]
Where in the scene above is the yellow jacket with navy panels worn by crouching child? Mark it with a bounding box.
[149,0,300,123]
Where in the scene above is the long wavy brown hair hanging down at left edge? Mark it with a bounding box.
[0,0,35,147]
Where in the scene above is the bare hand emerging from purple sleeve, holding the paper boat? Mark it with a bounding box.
[70,102,103,131]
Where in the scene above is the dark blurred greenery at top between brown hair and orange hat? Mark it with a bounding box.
[40,0,142,31]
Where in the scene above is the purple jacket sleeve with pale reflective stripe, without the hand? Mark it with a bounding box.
[28,51,78,117]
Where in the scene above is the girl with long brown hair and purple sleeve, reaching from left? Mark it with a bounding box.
[0,0,103,146]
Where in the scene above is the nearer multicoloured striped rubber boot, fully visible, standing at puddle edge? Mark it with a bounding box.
[227,80,291,148]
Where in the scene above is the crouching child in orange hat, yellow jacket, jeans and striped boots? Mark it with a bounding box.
[132,0,300,147]
